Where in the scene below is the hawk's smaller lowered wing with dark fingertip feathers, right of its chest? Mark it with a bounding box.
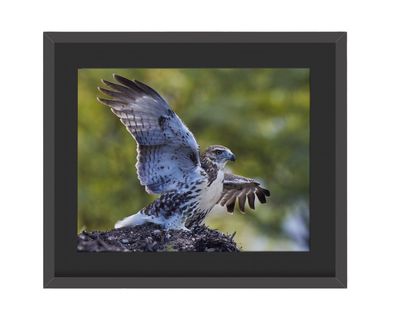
[219,173,270,212]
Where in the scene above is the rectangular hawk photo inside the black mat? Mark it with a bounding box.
[77,68,310,252]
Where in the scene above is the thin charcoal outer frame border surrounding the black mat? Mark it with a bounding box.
[43,32,347,288]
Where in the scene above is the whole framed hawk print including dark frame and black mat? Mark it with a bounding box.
[44,32,347,288]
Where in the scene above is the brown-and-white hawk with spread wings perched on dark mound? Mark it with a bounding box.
[97,74,270,230]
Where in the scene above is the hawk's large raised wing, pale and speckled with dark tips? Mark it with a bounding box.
[97,75,200,193]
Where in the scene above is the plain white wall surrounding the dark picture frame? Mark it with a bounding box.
[0,0,400,320]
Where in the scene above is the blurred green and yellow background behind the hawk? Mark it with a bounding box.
[77,69,310,251]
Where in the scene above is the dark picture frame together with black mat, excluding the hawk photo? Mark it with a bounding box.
[44,32,347,288]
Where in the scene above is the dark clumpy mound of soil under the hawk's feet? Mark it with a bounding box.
[77,223,240,252]
